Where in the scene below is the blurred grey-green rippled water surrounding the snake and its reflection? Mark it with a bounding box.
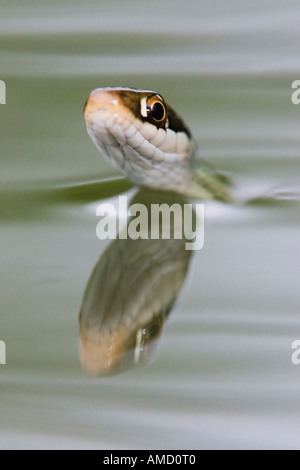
[0,0,300,449]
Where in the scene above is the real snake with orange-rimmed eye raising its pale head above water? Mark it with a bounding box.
[84,87,232,202]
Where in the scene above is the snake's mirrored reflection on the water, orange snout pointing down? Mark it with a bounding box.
[79,190,195,375]
